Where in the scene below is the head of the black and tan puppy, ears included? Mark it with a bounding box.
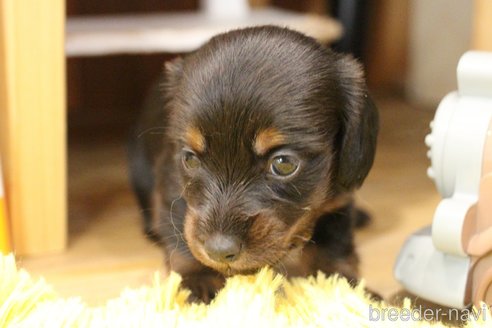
[166,27,377,273]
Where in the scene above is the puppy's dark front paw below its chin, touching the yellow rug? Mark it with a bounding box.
[181,272,225,304]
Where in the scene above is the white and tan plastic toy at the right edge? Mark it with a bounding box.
[394,52,492,308]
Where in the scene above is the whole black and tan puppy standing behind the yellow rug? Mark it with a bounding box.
[130,26,378,301]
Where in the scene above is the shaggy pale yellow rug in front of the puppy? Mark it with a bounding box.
[0,255,492,328]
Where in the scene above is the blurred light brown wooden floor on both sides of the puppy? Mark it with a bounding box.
[19,97,440,305]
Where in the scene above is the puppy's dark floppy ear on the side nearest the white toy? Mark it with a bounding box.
[335,56,379,191]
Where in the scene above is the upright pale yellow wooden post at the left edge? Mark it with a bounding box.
[0,0,67,254]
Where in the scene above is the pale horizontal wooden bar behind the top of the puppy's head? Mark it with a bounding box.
[66,8,342,56]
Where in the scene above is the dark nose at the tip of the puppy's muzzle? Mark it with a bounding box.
[203,234,241,263]
